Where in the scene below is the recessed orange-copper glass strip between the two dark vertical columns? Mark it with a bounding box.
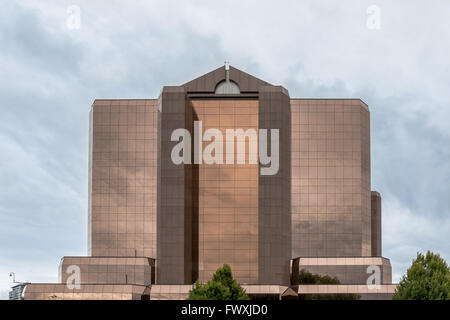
[192,99,259,283]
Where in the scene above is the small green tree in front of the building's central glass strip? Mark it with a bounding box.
[188,264,249,300]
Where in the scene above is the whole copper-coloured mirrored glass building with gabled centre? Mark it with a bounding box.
[25,67,391,299]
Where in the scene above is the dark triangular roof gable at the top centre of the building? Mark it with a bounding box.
[183,66,271,93]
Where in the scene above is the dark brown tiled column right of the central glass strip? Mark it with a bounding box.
[258,86,291,284]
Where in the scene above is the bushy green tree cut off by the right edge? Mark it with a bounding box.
[392,251,450,300]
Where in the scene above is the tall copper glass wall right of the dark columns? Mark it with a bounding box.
[291,99,371,257]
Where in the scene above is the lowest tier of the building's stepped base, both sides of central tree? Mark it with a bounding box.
[24,283,397,300]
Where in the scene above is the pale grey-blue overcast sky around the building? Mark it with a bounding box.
[0,0,450,299]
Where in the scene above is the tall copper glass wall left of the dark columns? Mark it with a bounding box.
[88,100,157,257]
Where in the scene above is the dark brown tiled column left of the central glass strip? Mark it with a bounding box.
[156,86,192,284]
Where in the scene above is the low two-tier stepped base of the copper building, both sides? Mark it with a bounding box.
[24,257,396,300]
